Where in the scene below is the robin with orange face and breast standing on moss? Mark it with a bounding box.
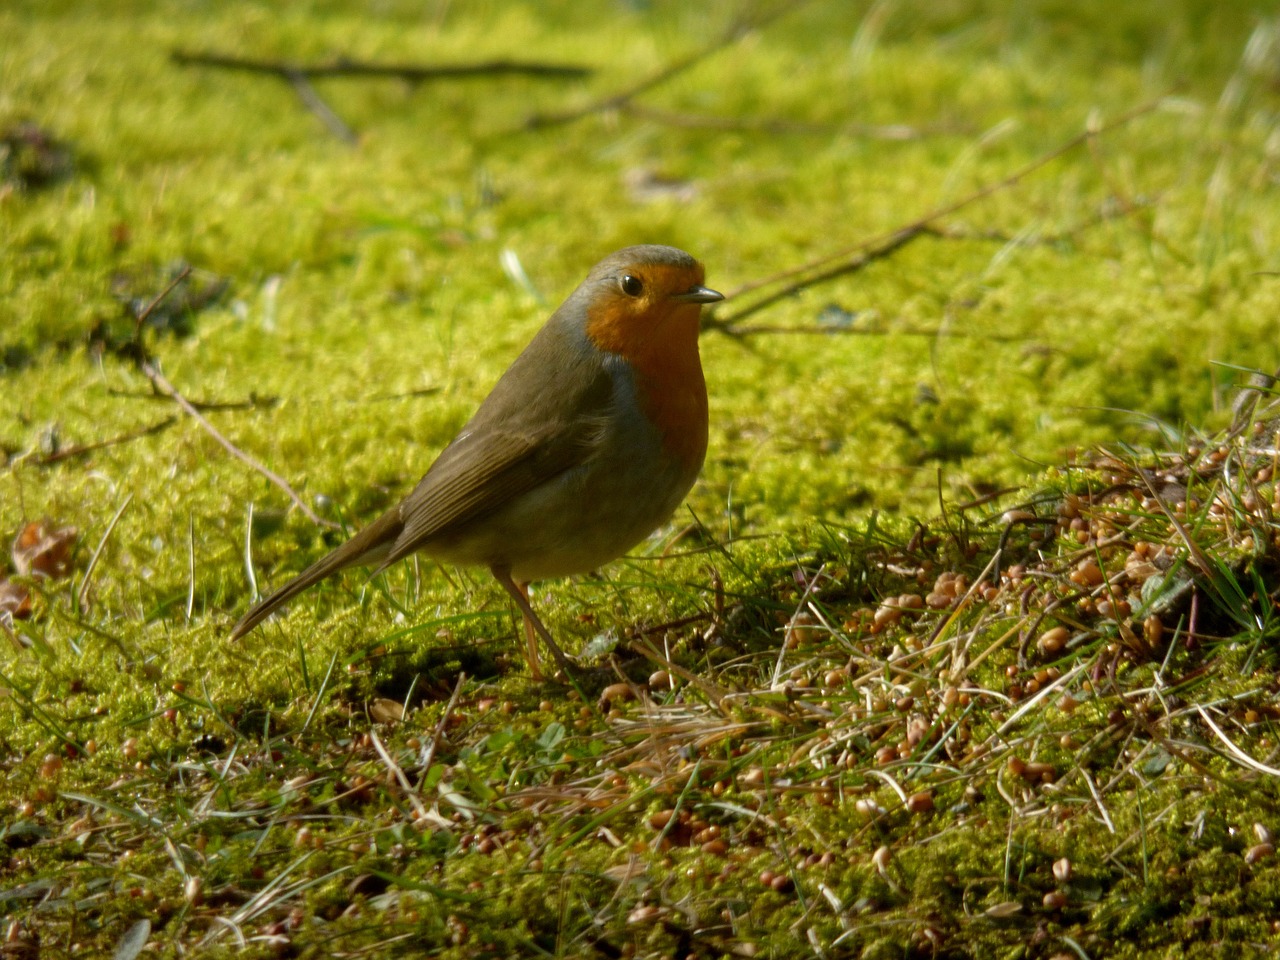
[230,244,724,681]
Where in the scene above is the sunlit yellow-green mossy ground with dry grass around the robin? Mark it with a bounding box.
[0,0,1280,957]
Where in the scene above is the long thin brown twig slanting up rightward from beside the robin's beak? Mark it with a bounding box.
[703,97,1164,335]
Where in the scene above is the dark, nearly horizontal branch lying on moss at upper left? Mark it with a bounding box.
[169,50,591,83]
